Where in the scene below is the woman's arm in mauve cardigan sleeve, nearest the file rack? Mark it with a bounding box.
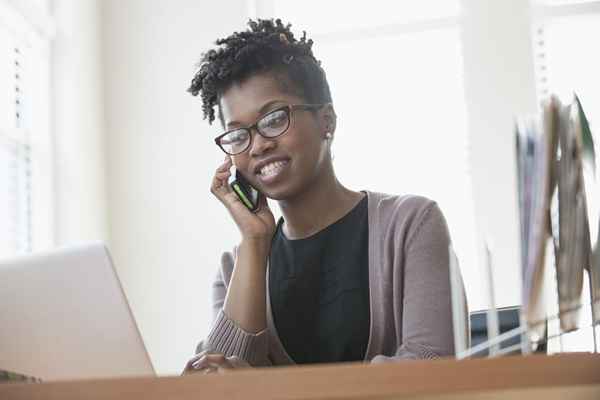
[372,203,464,363]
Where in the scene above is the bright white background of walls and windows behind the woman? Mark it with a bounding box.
[0,0,600,373]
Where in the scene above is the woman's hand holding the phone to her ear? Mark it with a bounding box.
[210,156,276,245]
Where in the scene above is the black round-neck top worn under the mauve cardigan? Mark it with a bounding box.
[269,195,370,364]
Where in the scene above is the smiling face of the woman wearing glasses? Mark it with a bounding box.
[220,74,330,200]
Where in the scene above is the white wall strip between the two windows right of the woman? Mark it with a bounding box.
[462,0,536,309]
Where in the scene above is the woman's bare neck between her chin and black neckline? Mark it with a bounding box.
[278,162,364,239]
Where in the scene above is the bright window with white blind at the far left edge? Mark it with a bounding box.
[0,3,52,257]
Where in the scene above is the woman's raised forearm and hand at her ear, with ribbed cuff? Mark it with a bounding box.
[184,155,275,371]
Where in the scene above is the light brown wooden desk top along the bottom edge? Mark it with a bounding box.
[0,354,600,400]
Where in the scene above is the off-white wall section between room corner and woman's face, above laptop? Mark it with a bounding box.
[102,0,247,373]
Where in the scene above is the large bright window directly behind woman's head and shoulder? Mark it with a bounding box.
[274,0,477,287]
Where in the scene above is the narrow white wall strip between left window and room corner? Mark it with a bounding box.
[51,0,109,245]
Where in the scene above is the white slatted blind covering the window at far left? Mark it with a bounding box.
[0,3,40,257]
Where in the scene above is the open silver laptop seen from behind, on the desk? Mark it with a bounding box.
[0,243,154,381]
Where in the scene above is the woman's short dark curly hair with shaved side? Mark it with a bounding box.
[188,19,331,123]
